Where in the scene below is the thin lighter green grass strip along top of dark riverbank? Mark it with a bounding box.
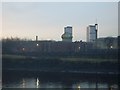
[2,54,118,63]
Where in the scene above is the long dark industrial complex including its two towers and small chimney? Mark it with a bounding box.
[2,24,118,55]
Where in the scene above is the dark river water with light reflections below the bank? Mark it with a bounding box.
[2,72,118,90]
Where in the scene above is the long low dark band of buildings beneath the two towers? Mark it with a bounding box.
[2,37,118,56]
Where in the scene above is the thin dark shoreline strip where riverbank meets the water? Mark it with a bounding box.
[2,69,119,76]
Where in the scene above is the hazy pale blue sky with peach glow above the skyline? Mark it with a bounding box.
[2,2,118,41]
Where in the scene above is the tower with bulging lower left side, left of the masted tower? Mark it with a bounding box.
[61,26,73,42]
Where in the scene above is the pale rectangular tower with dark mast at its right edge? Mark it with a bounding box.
[87,24,98,42]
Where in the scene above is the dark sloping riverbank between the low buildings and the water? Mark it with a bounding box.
[2,55,118,74]
